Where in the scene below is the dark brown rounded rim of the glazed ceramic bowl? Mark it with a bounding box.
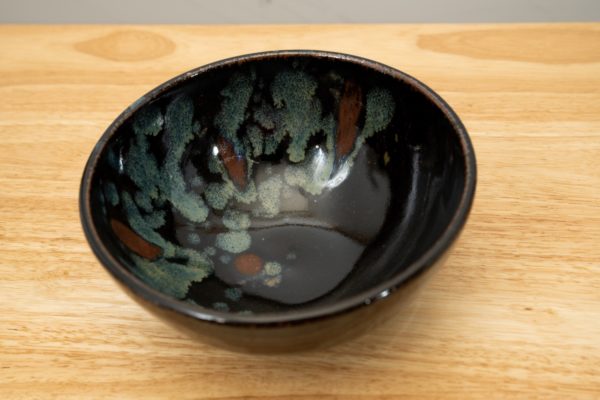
[79,50,477,327]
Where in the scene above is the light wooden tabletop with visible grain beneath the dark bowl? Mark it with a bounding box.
[0,24,600,400]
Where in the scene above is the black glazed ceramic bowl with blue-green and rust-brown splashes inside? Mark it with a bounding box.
[80,51,476,351]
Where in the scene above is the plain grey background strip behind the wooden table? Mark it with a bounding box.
[0,0,600,24]
